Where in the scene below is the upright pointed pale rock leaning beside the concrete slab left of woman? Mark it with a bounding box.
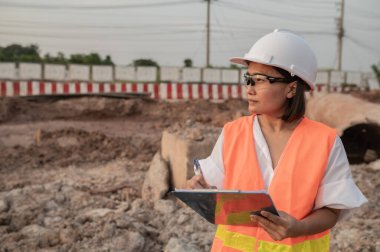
[141,152,169,200]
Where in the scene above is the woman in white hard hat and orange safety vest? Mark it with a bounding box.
[188,30,366,252]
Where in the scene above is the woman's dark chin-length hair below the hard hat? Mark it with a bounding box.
[273,67,310,122]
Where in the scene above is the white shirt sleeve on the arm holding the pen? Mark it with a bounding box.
[199,131,224,189]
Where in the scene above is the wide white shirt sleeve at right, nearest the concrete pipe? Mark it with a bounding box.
[314,136,367,220]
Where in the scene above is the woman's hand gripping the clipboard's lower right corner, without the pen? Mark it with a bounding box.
[251,211,302,241]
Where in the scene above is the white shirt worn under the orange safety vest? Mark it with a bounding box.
[199,116,367,219]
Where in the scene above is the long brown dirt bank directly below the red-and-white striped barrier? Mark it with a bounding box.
[0,97,246,126]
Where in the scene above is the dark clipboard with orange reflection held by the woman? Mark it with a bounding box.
[171,189,279,226]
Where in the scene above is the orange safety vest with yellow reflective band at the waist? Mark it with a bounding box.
[211,115,336,252]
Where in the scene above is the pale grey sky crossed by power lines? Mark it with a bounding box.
[0,0,380,72]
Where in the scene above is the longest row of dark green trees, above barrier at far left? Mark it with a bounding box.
[0,44,113,65]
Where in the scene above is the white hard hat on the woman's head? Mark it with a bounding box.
[230,29,317,90]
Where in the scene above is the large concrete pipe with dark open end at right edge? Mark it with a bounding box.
[307,94,380,164]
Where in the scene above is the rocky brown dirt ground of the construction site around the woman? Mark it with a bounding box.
[0,94,380,252]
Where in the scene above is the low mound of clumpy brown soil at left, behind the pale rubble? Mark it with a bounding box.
[0,128,159,174]
